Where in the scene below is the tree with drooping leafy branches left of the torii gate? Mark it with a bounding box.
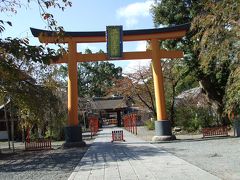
[0,0,71,141]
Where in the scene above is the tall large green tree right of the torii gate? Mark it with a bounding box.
[152,0,240,124]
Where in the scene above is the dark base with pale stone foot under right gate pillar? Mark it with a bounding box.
[152,120,176,142]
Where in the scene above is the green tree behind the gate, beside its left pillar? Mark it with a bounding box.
[61,49,122,97]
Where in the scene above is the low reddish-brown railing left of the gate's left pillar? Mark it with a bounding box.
[25,139,52,150]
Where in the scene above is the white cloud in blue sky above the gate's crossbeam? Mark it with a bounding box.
[117,0,153,27]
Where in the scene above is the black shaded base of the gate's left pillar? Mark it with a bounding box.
[63,126,86,147]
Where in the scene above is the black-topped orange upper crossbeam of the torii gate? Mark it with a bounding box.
[31,24,189,43]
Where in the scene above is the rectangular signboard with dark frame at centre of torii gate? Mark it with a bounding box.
[106,26,123,59]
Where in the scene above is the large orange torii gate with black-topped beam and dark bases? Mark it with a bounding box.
[31,24,189,142]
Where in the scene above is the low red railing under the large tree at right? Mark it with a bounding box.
[202,126,228,138]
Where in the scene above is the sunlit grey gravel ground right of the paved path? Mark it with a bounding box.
[138,127,240,180]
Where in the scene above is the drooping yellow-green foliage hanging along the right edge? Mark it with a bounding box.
[192,0,240,113]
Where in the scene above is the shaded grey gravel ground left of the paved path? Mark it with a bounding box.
[0,134,93,180]
